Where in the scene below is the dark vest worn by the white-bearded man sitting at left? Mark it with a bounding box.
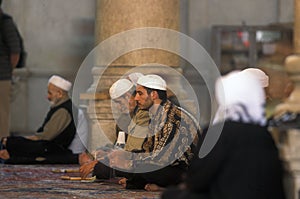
[37,99,77,148]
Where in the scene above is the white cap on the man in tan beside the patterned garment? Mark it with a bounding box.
[109,79,133,99]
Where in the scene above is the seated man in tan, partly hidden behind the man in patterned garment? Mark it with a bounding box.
[79,79,149,179]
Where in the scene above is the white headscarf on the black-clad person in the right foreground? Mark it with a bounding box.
[214,71,266,125]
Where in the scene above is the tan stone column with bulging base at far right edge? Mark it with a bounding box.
[275,0,300,199]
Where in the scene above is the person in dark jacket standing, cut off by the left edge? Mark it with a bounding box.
[0,0,21,137]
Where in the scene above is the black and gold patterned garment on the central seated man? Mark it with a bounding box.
[139,101,200,167]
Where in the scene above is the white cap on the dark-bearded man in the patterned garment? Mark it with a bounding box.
[137,75,167,91]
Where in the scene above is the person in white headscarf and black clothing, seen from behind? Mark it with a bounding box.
[162,71,285,199]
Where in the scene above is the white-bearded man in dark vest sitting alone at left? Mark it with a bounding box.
[0,75,78,163]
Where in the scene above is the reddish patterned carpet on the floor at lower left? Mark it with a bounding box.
[0,164,160,199]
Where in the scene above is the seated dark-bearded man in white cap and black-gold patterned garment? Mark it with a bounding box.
[110,75,201,191]
